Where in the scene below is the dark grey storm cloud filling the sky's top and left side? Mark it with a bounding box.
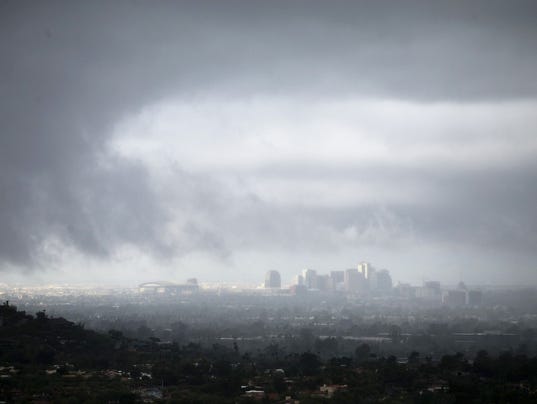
[0,1,537,265]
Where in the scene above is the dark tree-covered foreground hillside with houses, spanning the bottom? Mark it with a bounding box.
[0,302,537,403]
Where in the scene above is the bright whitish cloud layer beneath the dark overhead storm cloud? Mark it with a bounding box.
[110,98,537,251]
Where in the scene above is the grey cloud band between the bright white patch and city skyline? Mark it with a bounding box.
[189,157,537,255]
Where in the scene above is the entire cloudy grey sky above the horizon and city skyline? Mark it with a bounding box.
[0,0,537,285]
